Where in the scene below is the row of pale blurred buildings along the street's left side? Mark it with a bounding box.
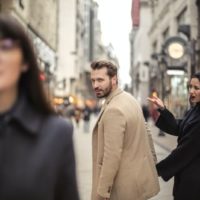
[0,0,117,104]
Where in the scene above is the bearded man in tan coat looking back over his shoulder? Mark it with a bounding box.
[91,61,159,200]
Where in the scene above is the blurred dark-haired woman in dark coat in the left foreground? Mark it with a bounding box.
[0,15,79,200]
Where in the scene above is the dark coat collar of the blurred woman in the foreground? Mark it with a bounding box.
[10,96,44,135]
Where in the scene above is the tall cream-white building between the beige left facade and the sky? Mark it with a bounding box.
[56,0,104,99]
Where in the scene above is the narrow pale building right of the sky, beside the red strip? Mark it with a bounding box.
[130,0,152,105]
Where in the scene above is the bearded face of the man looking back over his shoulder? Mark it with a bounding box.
[91,67,116,98]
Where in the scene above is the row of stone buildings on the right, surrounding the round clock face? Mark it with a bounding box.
[130,0,199,117]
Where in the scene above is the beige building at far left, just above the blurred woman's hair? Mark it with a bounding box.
[0,0,58,98]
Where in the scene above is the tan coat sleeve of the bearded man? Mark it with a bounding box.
[97,109,126,198]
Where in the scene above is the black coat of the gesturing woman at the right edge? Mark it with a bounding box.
[156,105,200,200]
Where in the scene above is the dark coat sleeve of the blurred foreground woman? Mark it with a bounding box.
[55,124,79,200]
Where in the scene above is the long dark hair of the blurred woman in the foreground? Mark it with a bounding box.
[0,14,54,115]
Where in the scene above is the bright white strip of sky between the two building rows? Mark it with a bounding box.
[96,0,131,85]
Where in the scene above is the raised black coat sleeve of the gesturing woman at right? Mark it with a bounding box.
[156,109,180,136]
